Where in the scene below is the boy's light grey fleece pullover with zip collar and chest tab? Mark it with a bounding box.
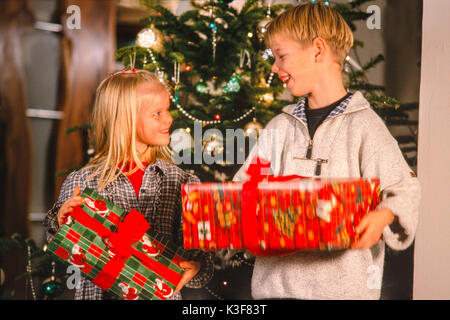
[233,91,420,299]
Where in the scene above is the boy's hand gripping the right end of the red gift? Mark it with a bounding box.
[352,208,394,249]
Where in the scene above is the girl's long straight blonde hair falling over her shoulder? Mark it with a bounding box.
[85,70,172,190]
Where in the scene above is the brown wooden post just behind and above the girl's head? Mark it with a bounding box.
[55,0,116,197]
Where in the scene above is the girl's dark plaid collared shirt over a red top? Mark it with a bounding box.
[44,159,214,300]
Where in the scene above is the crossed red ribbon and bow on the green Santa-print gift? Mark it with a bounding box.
[70,207,181,290]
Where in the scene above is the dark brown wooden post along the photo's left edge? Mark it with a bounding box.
[0,0,33,298]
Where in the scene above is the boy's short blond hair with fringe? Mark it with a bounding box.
[265,2,353,68]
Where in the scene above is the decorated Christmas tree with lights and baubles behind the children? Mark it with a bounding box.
[116,0,416,185]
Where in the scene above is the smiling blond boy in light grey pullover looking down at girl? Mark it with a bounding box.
[234,3,420,299]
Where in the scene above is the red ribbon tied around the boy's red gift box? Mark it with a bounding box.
[241,157,305,256]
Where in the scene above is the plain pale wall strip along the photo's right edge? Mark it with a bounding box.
[413,0,450,299]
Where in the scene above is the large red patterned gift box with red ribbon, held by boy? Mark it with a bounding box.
[182,158,380,255]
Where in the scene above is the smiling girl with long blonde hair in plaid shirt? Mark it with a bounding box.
[44,69,213,299]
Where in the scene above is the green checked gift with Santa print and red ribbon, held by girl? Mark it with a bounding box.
[48,188,187,300]
